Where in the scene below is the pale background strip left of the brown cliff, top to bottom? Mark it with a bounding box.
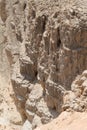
[0,0,23,130]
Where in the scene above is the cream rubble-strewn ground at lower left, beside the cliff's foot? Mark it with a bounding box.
[0,74,23,130]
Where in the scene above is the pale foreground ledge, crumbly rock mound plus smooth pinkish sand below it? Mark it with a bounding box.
[35,70,87,130]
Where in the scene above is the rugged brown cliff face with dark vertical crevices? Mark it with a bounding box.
[0,0,87,129]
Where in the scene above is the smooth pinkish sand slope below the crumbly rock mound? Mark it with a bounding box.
[35,112,87,130]
